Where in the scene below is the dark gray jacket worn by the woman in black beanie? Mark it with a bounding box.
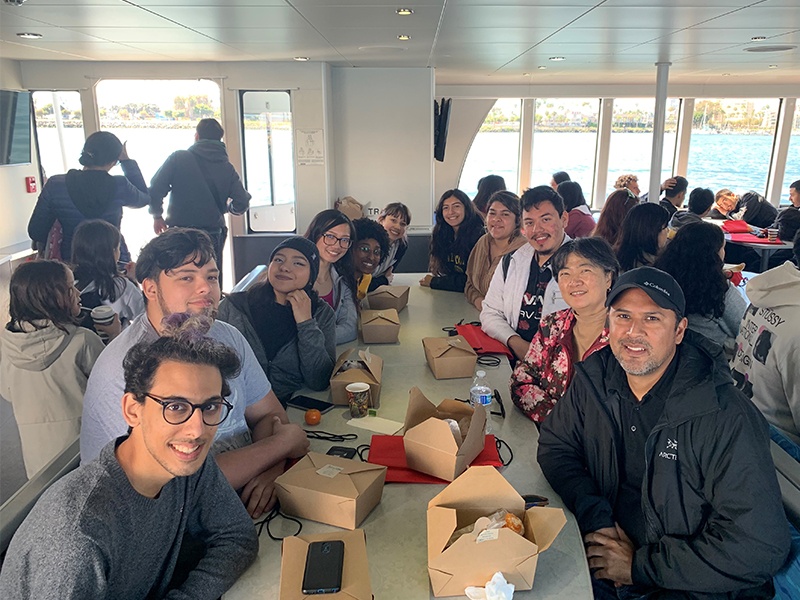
[217,292,336,404]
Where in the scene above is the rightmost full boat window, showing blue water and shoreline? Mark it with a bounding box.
[686,98,780,200]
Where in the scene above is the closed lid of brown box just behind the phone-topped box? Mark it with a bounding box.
[275,452,386,498]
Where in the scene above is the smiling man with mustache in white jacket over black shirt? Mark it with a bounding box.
[481,185,570,360]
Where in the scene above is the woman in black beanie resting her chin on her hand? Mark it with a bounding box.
[217,236,336,405]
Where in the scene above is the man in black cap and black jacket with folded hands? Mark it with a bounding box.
[538,267,789,599]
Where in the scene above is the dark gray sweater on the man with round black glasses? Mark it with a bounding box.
[0,438,258,600]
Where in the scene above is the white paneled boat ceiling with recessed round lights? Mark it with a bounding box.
[0,0,800,86]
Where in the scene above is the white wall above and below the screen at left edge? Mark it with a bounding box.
[0,58,42,248]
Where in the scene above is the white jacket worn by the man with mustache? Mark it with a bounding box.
[481,234,570,344]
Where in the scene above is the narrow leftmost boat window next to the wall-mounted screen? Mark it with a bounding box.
[33,91,84,177]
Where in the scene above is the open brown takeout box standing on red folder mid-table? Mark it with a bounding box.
[403,387,488,480]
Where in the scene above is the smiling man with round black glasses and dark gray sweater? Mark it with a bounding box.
[0,329,258,600]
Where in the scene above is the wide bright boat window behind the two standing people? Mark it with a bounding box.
[95,79,223,260]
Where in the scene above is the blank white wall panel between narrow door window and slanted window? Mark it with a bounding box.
[331,68,434,228]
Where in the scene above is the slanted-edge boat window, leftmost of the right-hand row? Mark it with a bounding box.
[458,98,520,197]
